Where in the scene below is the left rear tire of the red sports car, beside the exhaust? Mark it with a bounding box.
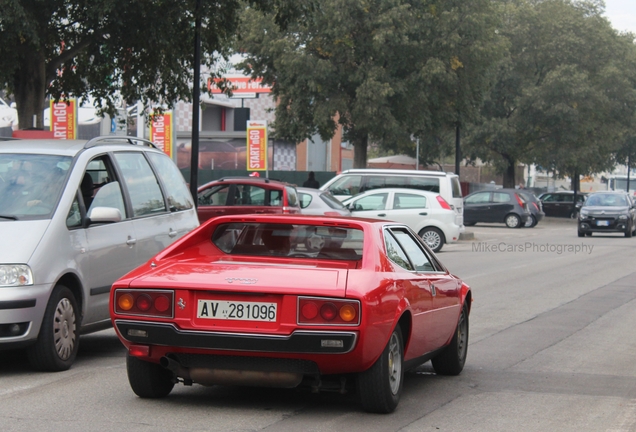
[126,354,175,399]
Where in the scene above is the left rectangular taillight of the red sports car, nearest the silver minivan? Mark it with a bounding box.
[114,289,174,318]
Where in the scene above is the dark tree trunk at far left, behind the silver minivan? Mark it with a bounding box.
[13,49,46,129]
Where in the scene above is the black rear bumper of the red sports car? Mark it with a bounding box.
[115,320,358,354]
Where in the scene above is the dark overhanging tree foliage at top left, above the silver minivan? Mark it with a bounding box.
[0,0,312,128]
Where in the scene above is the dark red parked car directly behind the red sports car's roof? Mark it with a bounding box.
[197,177,300,223]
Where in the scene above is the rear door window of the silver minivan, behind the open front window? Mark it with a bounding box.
[115,152,167,217]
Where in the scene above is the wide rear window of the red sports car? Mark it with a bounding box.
[212,222,363,260]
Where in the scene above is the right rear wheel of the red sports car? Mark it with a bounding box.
[357,326,404,414]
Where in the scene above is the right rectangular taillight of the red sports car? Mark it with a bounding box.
[298,297,360,325]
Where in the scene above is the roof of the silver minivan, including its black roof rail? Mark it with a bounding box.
[0,136,158,157]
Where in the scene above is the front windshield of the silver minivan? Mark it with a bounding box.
[0,153,71,220]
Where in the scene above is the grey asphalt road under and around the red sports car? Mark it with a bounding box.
[0,220,636,432]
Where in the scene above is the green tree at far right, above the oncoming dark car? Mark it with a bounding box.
[468,0,636,187]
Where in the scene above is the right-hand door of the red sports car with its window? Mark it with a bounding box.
[384,227,435,358]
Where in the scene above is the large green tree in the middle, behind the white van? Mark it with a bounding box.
[237,0,500,167]
